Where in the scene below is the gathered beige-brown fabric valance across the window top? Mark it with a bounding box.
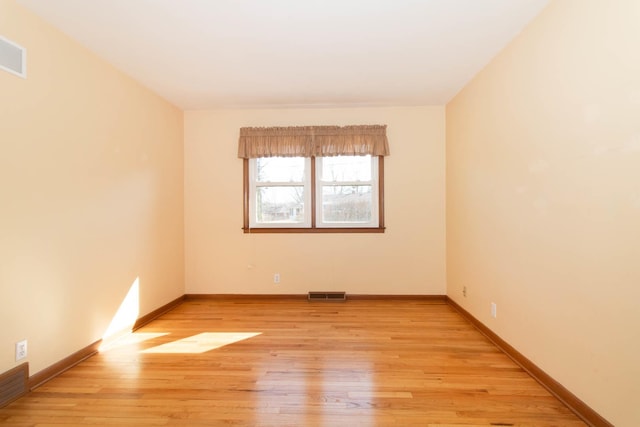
[238,125,389,159]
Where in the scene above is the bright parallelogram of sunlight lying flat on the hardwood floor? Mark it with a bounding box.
[141,332,261,354]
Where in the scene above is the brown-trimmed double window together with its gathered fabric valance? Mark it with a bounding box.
[238,125,388,233]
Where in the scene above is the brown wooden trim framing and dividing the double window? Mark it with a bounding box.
[242,156,386,234]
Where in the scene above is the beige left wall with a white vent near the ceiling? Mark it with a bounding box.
[0,0,184,373]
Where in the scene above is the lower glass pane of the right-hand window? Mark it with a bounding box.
[322,185,373,223]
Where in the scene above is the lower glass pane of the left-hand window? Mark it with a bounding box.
[256,186,304,224]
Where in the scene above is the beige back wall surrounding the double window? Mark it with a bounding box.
[185,107,446,294]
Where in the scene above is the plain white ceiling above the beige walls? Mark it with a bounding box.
[18,0,548,109]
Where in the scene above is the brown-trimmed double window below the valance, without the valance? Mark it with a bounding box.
[244,155,384,232]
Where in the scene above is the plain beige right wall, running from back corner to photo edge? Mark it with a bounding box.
[446,0,640,426]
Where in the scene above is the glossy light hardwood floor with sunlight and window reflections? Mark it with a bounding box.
[0,300,584,426]
